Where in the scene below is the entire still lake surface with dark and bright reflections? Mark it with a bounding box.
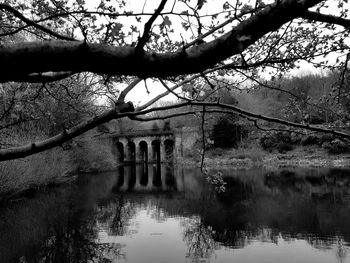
[0,166,350,263]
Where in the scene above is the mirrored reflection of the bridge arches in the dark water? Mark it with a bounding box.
[114,163,184,192]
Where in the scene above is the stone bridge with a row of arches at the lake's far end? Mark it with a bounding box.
[98,127,209,164]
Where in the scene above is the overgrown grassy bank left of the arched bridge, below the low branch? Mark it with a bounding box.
[0,128,117,199]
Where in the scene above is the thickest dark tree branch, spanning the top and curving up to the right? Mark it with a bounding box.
[0,0,322,82]
